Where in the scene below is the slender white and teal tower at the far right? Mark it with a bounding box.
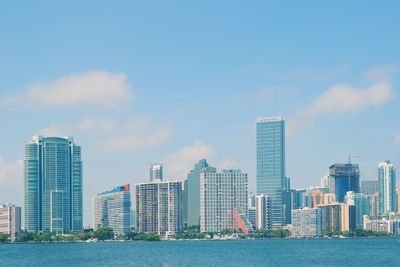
[378,160,397,215]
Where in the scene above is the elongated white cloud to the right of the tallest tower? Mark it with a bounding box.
[287,81,394,136]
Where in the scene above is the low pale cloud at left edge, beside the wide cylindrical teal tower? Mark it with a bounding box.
[0,158,24,205]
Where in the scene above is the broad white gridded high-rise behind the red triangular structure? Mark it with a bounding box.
[200,170,248,232]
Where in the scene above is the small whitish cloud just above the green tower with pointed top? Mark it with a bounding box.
[164,139,213,179]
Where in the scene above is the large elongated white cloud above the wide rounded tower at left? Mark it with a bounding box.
[0,71,132,108]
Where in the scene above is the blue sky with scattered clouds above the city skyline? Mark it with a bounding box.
[0,0,400,224]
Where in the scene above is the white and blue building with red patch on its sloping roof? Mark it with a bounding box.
[93,184,131,234]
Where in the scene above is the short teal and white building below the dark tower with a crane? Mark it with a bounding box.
[344,191,371,229]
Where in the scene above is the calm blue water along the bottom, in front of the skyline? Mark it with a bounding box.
[0,239,400,266]
